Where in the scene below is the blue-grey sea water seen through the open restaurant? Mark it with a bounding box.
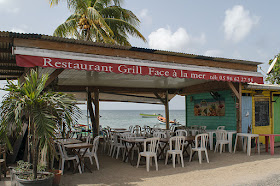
[79,110,186,128]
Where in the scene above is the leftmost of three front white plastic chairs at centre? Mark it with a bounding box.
[137,138,159,172]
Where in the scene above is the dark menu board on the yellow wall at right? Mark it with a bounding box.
[255,101,269,126]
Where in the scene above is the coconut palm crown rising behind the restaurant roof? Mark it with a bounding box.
[50,0,146,46]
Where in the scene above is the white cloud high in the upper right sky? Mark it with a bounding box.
[223,5,260,43]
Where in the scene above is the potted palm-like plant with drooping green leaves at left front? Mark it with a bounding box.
[0,70,80,179]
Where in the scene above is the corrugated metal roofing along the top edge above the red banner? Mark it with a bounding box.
[0,31,262,65]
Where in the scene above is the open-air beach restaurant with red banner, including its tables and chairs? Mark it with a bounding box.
[0,32,274,179]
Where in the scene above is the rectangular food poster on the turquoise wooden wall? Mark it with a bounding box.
[194,99,225,116]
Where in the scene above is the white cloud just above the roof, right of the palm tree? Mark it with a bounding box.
[148,27,206,53]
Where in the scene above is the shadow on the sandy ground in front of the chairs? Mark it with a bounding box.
[60,143,280,186]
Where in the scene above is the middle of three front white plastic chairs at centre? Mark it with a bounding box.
[165,136,185,168]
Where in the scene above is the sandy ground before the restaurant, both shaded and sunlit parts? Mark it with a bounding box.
[0,146,280,186]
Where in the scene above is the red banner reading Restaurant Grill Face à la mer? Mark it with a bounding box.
[16,55,263,84]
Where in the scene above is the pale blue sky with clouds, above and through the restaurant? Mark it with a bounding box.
[0,0,280,110]
